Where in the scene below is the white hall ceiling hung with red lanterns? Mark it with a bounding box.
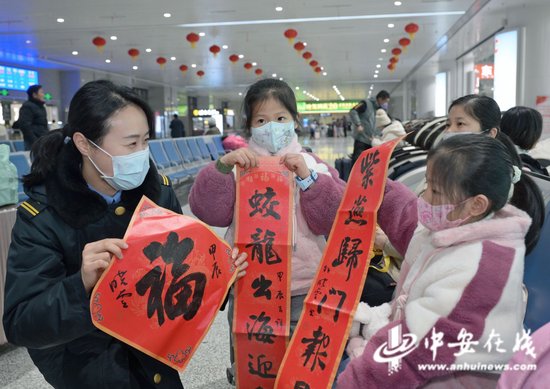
[0,0,473,100]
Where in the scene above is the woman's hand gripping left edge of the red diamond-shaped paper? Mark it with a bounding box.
[80,238,128,294]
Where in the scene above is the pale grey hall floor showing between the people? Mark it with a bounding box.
[0,137,353,389]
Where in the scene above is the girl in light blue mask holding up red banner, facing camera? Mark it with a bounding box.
[189,79,345,380]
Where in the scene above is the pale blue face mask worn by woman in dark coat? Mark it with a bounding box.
[88,140,149,190]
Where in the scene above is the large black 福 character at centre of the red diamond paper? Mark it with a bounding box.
[136,232,206,326]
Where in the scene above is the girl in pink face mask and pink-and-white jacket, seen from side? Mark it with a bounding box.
[337,135,544,389]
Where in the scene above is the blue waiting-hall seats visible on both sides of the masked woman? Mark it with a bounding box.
[7,135,225,202]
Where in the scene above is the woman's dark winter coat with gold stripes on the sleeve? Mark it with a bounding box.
[4,157,182,389]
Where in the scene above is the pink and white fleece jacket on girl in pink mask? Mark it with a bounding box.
[338,180,531,389]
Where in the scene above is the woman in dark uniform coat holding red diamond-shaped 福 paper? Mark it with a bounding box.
[4,81,248,388]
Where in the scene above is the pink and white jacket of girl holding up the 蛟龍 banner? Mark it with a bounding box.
[189,136,346,296]
